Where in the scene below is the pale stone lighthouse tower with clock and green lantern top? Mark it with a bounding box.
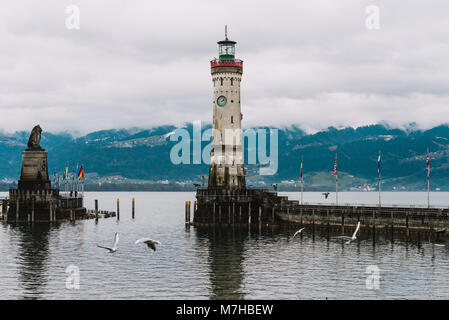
[208,27,245,188]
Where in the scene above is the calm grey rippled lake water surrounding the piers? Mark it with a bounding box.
[0,192,449,299]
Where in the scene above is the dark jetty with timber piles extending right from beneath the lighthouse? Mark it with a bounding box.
[192,188,449,237]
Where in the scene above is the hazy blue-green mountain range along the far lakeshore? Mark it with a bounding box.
[0,124,449,191]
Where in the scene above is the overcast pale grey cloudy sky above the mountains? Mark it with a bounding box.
[0,0,449,134]
